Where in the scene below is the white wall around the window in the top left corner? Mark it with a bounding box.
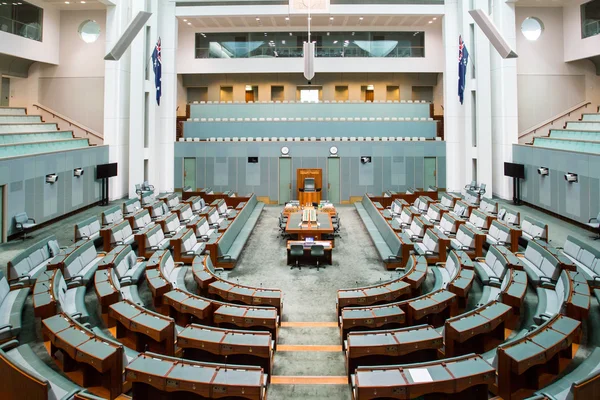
[0,0,61,64]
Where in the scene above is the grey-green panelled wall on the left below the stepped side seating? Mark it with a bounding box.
[0,146,108,235]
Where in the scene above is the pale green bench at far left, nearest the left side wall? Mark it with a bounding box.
[7,235,61,286]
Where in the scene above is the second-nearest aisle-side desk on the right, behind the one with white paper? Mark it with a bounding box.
[345,325,444,374]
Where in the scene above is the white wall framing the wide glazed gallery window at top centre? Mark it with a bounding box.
[177,21,444,74]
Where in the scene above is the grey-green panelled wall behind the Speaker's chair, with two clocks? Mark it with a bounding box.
[174,141,446,200]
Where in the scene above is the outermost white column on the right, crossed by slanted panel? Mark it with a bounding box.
[491,1,519,199]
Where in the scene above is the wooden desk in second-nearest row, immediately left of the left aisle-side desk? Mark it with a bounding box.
[108,300,177,356]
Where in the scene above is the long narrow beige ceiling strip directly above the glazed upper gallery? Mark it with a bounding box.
[179,15,440,31]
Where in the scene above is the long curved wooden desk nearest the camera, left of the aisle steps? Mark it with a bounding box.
[125,353,267,400]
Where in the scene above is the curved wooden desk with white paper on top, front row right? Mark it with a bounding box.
[352,354,496,400]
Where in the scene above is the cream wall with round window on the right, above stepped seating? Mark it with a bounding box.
[516,7,600,132]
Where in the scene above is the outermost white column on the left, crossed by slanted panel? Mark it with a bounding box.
[104,1,130,200]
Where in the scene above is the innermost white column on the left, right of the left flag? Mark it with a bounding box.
[151,0,178,192]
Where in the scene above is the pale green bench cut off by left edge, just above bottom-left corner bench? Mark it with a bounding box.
[0,272,29,342]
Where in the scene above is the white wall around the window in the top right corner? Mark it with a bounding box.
[563,0,600,61]
